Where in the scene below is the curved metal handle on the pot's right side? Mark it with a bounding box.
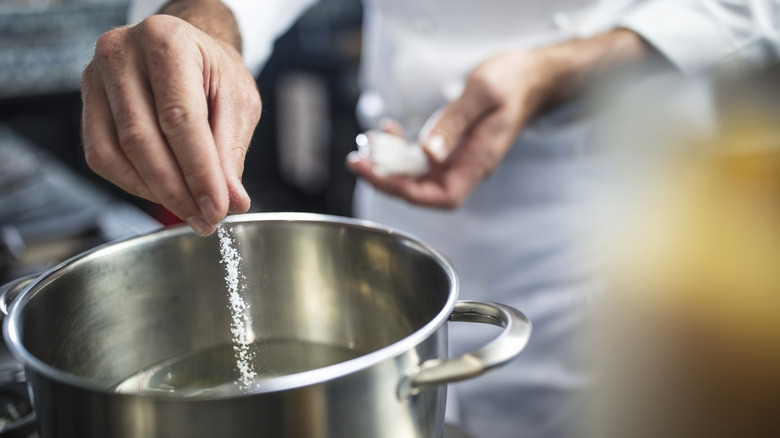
[399,301,531,398]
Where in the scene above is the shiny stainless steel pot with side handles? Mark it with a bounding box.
[0,214,530,438]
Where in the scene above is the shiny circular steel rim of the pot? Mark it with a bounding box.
[3,213,459,401]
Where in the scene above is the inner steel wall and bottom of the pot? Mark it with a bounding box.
[12,215,456,395]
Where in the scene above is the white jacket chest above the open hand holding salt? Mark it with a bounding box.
[358,0,631,134]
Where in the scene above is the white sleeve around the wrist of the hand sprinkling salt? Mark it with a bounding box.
[128,0,317,76]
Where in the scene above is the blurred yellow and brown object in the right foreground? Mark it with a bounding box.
[599,98,780,438]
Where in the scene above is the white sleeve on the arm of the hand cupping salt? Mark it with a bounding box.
[620,0,780,74]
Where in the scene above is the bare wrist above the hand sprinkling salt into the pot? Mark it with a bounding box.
[160,0,241,53]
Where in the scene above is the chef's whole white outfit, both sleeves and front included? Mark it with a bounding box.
[131,0,780,438]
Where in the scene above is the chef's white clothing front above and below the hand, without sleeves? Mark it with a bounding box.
[355,0,616,438]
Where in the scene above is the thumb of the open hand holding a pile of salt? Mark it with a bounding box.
[420,87,491,163]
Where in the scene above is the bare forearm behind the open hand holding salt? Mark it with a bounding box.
[538,29,660,102]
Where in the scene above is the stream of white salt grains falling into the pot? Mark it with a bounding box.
[217,225,257,389]
